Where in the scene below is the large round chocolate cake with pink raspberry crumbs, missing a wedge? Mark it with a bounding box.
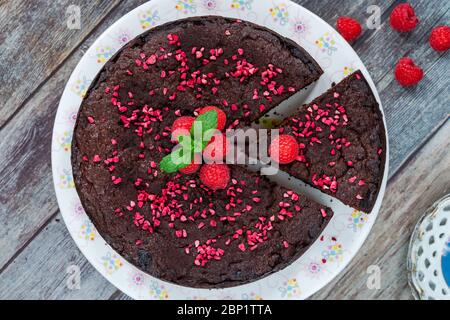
[72,17,333,288]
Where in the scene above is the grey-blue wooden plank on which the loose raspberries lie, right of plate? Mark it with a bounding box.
[354,1,450,174]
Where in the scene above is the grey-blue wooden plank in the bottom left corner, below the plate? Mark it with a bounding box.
[0,215,116,299]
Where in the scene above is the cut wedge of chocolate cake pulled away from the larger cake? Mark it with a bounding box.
[280,71,386,212]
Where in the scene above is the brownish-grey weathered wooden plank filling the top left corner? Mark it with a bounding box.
[0,0,123,128]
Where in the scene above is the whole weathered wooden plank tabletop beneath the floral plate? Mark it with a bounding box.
[0,0,450,299]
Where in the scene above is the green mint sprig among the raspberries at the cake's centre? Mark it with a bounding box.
[159,110,217,173]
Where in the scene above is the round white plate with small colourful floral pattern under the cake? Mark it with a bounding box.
[52,0,389,299]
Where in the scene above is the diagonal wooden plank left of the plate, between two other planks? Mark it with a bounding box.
[0,0,149,270]
